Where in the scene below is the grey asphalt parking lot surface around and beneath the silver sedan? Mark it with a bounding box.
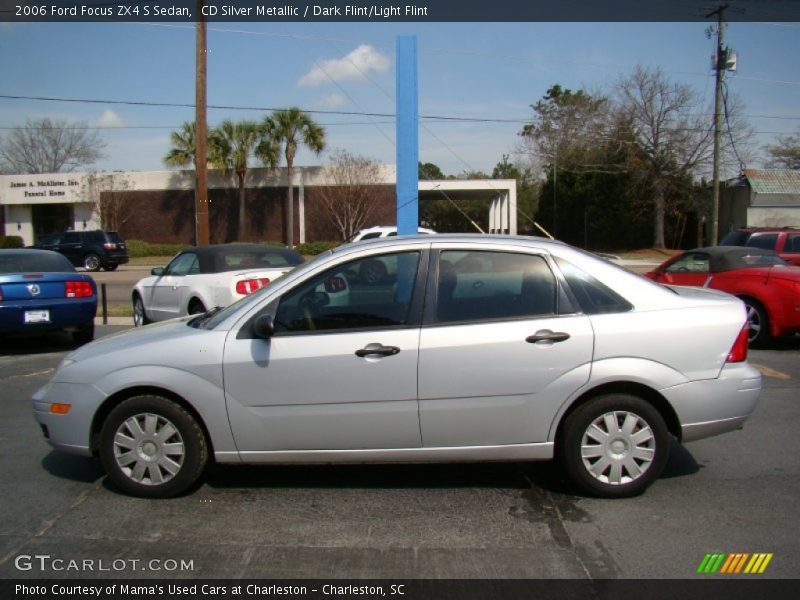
[0,327,800,578]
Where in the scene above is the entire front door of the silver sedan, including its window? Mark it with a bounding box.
[223,247,427,452]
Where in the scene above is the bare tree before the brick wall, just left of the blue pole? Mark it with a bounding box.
[320,150,381,241]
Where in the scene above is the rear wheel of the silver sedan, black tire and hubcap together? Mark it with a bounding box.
[557,394,669,498]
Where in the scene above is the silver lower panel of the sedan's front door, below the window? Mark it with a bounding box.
[219,328,421,451]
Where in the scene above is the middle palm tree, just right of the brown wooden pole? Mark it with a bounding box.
[209,119,261,240]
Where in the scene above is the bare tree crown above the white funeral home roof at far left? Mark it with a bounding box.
[0,119,106,173]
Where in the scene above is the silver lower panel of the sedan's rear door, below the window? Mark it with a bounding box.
[419,316,594,447]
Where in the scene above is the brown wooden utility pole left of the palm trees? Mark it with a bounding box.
[194,0,210,246]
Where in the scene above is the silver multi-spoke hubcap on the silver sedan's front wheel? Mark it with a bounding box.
[114,413,186,485]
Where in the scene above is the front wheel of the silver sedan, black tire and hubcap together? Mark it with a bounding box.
[100,395,208,498]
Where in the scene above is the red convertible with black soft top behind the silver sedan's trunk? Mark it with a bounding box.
[645,246,800,346]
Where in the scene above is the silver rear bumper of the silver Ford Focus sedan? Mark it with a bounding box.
[661,363,761,442]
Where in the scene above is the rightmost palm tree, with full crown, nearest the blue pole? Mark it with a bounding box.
[258,106,325,248]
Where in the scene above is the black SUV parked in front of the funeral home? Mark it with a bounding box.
[33,229,128,271]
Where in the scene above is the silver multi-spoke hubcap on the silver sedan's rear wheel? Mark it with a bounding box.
[581,411,656,485]
